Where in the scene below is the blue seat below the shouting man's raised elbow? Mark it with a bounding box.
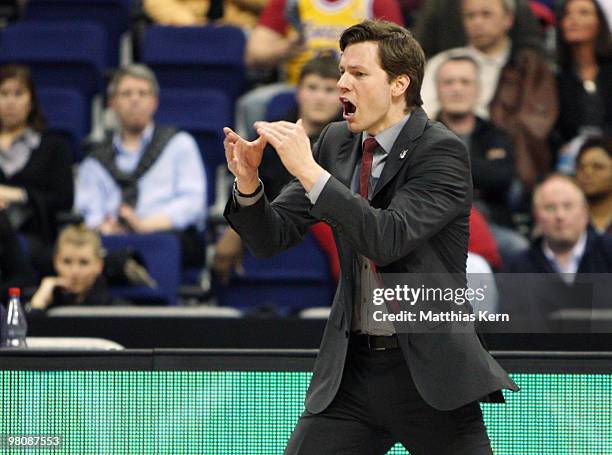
[217,233,335,315]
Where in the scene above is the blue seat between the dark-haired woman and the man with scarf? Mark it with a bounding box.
[37,88,90,161]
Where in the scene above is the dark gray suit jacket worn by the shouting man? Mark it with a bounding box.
[225,108,518,413]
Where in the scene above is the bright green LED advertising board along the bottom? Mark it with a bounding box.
[0,371,612,455]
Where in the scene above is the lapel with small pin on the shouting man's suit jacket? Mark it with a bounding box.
[372,107,427,200]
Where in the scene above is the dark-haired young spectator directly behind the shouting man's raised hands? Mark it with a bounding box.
[213,54,342,284]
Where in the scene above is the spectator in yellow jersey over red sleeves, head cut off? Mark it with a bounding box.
[236,0,403,138]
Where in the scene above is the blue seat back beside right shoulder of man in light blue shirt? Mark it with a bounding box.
[155,89,232,205]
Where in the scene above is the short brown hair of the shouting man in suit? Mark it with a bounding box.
[340,20,425,107]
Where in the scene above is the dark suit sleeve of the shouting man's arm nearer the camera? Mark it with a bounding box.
[311,127,471,266]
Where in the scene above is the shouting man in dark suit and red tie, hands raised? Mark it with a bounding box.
[224,21,518,455]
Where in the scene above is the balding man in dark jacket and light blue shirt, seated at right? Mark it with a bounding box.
[498,174,612,331]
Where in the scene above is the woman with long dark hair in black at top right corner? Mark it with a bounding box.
[556,0,612,145]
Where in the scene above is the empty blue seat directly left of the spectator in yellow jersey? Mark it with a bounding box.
[142,25,246,107]
